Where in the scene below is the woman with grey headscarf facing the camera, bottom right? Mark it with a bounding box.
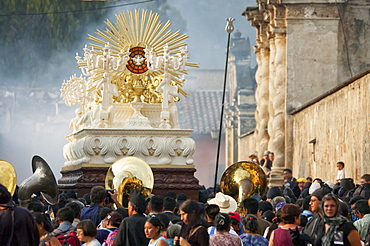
[315,193,361,246]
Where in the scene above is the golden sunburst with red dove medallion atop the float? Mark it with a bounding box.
[78,10,198,103]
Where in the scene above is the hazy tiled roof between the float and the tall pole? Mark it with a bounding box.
[177,90,222,134]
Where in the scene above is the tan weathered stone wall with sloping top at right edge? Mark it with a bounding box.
[292,70,370,182]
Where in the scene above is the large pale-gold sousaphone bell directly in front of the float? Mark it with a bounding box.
[105,156,154,207]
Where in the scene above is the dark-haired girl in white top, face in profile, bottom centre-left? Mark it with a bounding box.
[144,216,168,246]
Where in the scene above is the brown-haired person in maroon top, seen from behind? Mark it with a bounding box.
[269,204,302,246]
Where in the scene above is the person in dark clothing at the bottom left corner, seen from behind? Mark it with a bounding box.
[0,184,40,246]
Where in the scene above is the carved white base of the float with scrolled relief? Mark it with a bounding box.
[63,129,195,166]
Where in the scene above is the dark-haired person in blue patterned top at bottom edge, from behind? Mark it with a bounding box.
[240,214,268,246]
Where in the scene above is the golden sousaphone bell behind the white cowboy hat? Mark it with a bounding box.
[220,161,267,212]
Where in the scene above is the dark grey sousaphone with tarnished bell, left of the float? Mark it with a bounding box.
[18,155,59,207]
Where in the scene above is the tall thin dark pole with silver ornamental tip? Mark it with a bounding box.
[213,18,235,195]
